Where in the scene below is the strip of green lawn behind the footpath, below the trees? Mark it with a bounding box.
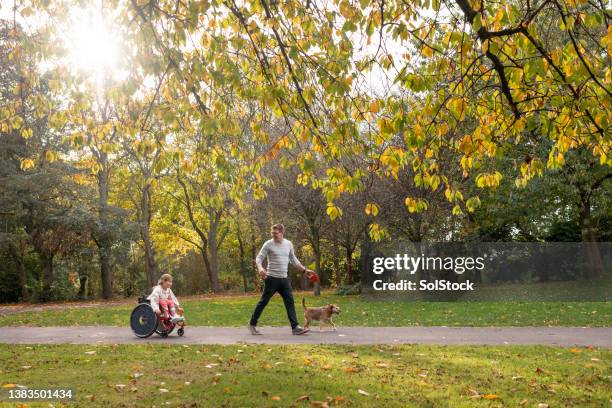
[0,293,612,326]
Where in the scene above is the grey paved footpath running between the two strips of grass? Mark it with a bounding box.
[0,326,612,348]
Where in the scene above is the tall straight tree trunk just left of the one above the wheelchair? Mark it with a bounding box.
[96,164,113,299]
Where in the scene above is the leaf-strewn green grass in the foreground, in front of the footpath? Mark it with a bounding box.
[0,345,612,407]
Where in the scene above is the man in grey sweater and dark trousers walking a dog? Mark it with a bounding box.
[248,224,314,335]
